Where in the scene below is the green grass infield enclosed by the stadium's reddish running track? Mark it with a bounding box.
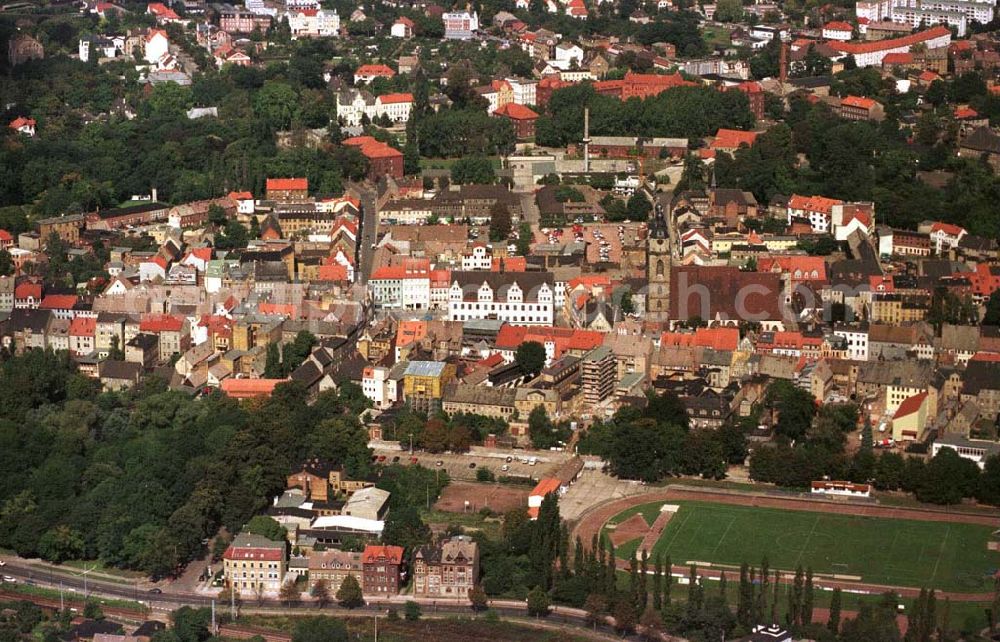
[609,501,1000,592]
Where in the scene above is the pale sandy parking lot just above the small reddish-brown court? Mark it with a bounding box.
[373,444,570,480]
